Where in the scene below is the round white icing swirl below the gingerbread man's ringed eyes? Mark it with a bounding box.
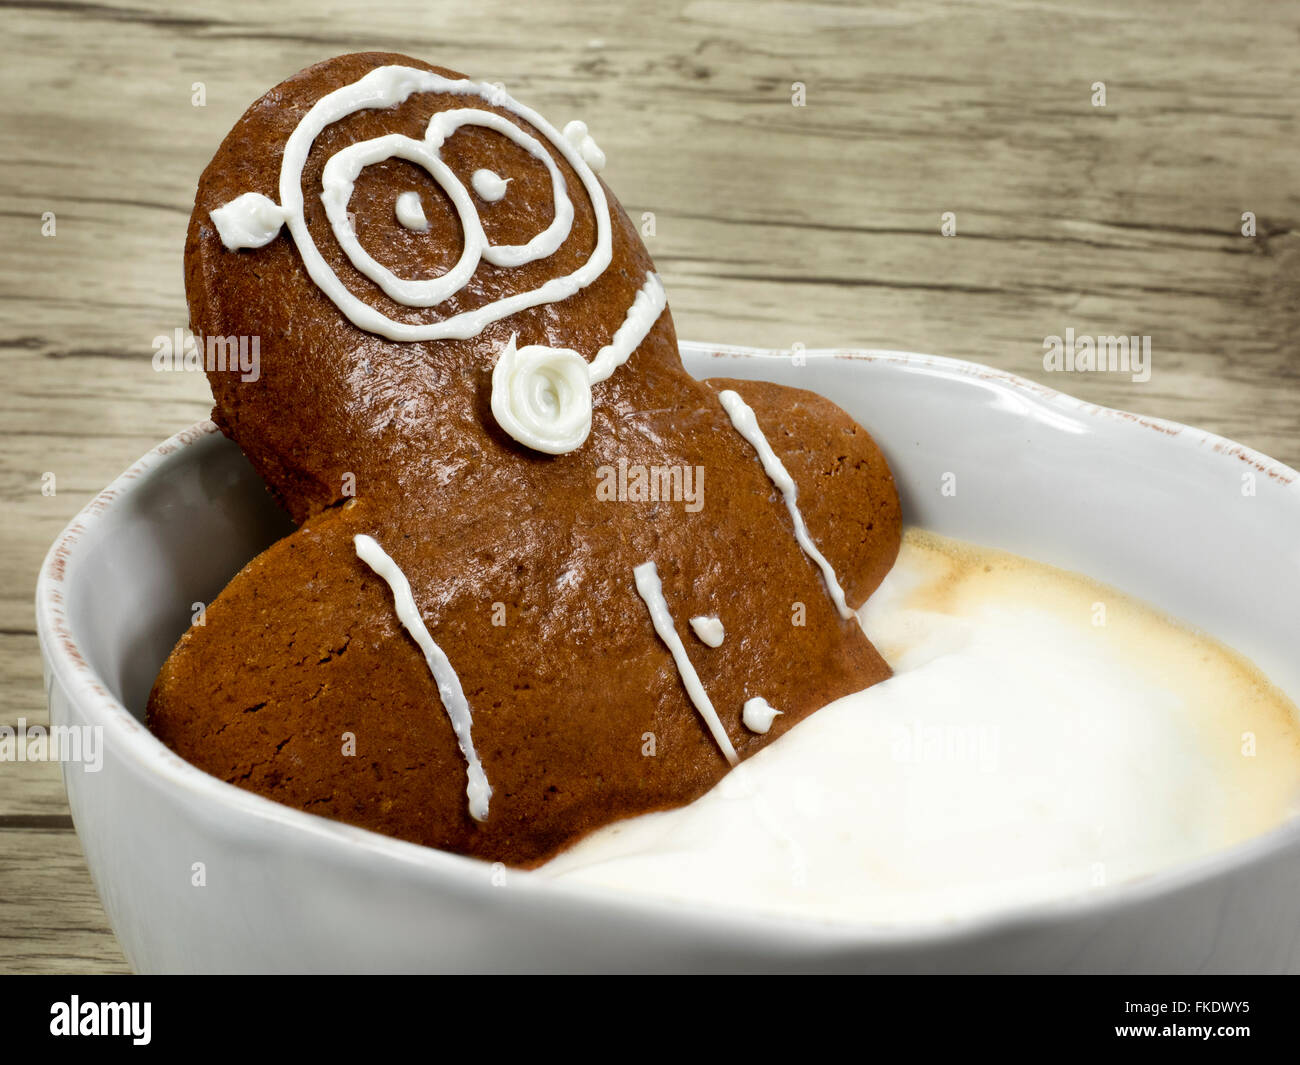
[491,333,592,455]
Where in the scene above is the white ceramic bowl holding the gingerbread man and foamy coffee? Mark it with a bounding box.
[36,345,1300,971]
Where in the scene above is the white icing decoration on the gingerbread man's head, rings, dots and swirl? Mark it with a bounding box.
[211,66,667,454]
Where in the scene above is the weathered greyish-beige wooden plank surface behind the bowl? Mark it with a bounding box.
[0,0,1300,971]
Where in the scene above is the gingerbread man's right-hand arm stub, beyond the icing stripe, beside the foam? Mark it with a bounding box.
[705,377,902,609]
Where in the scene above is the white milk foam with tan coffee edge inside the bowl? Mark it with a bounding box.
[538,531,1300,923]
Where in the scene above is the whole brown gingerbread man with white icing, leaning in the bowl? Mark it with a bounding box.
[150,53,900,865]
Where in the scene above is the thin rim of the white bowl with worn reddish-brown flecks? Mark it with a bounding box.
[35,341,1300,949]
